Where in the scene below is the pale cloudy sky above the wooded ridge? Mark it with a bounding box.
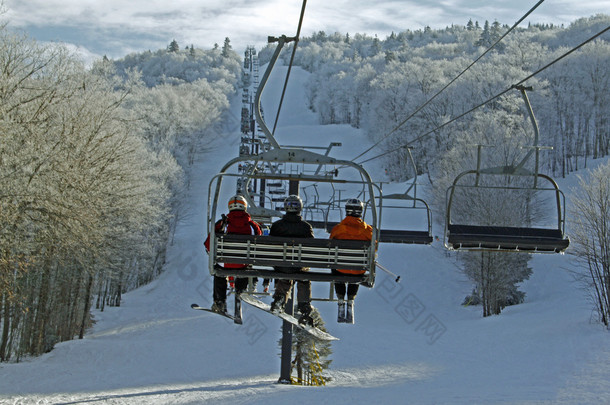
[0,0,610,59]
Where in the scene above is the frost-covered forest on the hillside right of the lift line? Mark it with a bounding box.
[268,15,610,178]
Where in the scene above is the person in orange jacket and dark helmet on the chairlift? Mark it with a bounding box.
[330,198,373,323]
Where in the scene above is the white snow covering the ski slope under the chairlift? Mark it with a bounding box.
[0,67,610,404]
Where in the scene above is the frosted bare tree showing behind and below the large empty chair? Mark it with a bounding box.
[433,108,544,316]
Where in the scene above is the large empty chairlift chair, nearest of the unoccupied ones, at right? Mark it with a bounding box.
[444,86,570,253]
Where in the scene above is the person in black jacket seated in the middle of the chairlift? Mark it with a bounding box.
[269,195,314,325]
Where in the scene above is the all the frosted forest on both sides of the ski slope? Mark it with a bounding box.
[0,15,610,361]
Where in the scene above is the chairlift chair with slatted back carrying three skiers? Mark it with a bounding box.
[207,148,379,287]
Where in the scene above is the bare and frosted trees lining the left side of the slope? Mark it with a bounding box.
[0,26,240,361]
